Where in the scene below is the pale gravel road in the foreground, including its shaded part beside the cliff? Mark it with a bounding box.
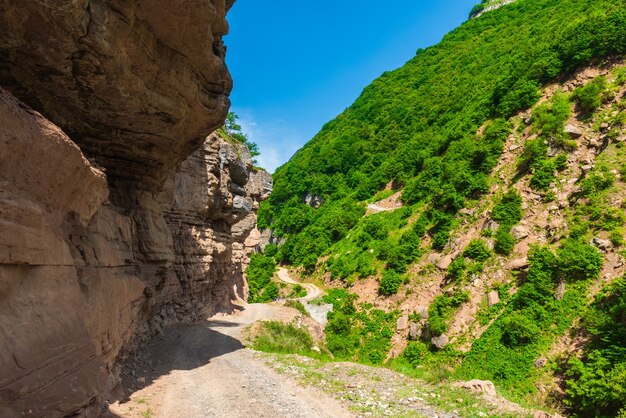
[111,305,351,418]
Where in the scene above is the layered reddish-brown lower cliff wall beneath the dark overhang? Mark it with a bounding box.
[0,86,271,417]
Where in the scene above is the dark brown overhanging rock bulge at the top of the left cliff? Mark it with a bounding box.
[0,0,234,192]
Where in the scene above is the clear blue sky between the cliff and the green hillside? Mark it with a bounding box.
[225,0,480,172]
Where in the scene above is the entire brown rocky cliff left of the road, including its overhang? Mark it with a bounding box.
[0,0,271,417]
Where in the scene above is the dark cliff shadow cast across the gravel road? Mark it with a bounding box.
[105,320,245,418]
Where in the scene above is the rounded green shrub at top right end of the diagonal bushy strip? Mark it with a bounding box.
[557,239,602,280]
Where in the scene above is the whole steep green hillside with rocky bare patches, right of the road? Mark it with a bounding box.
[259,0,626,416]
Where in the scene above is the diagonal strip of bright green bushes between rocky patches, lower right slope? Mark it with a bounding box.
[458,240,602,397]
